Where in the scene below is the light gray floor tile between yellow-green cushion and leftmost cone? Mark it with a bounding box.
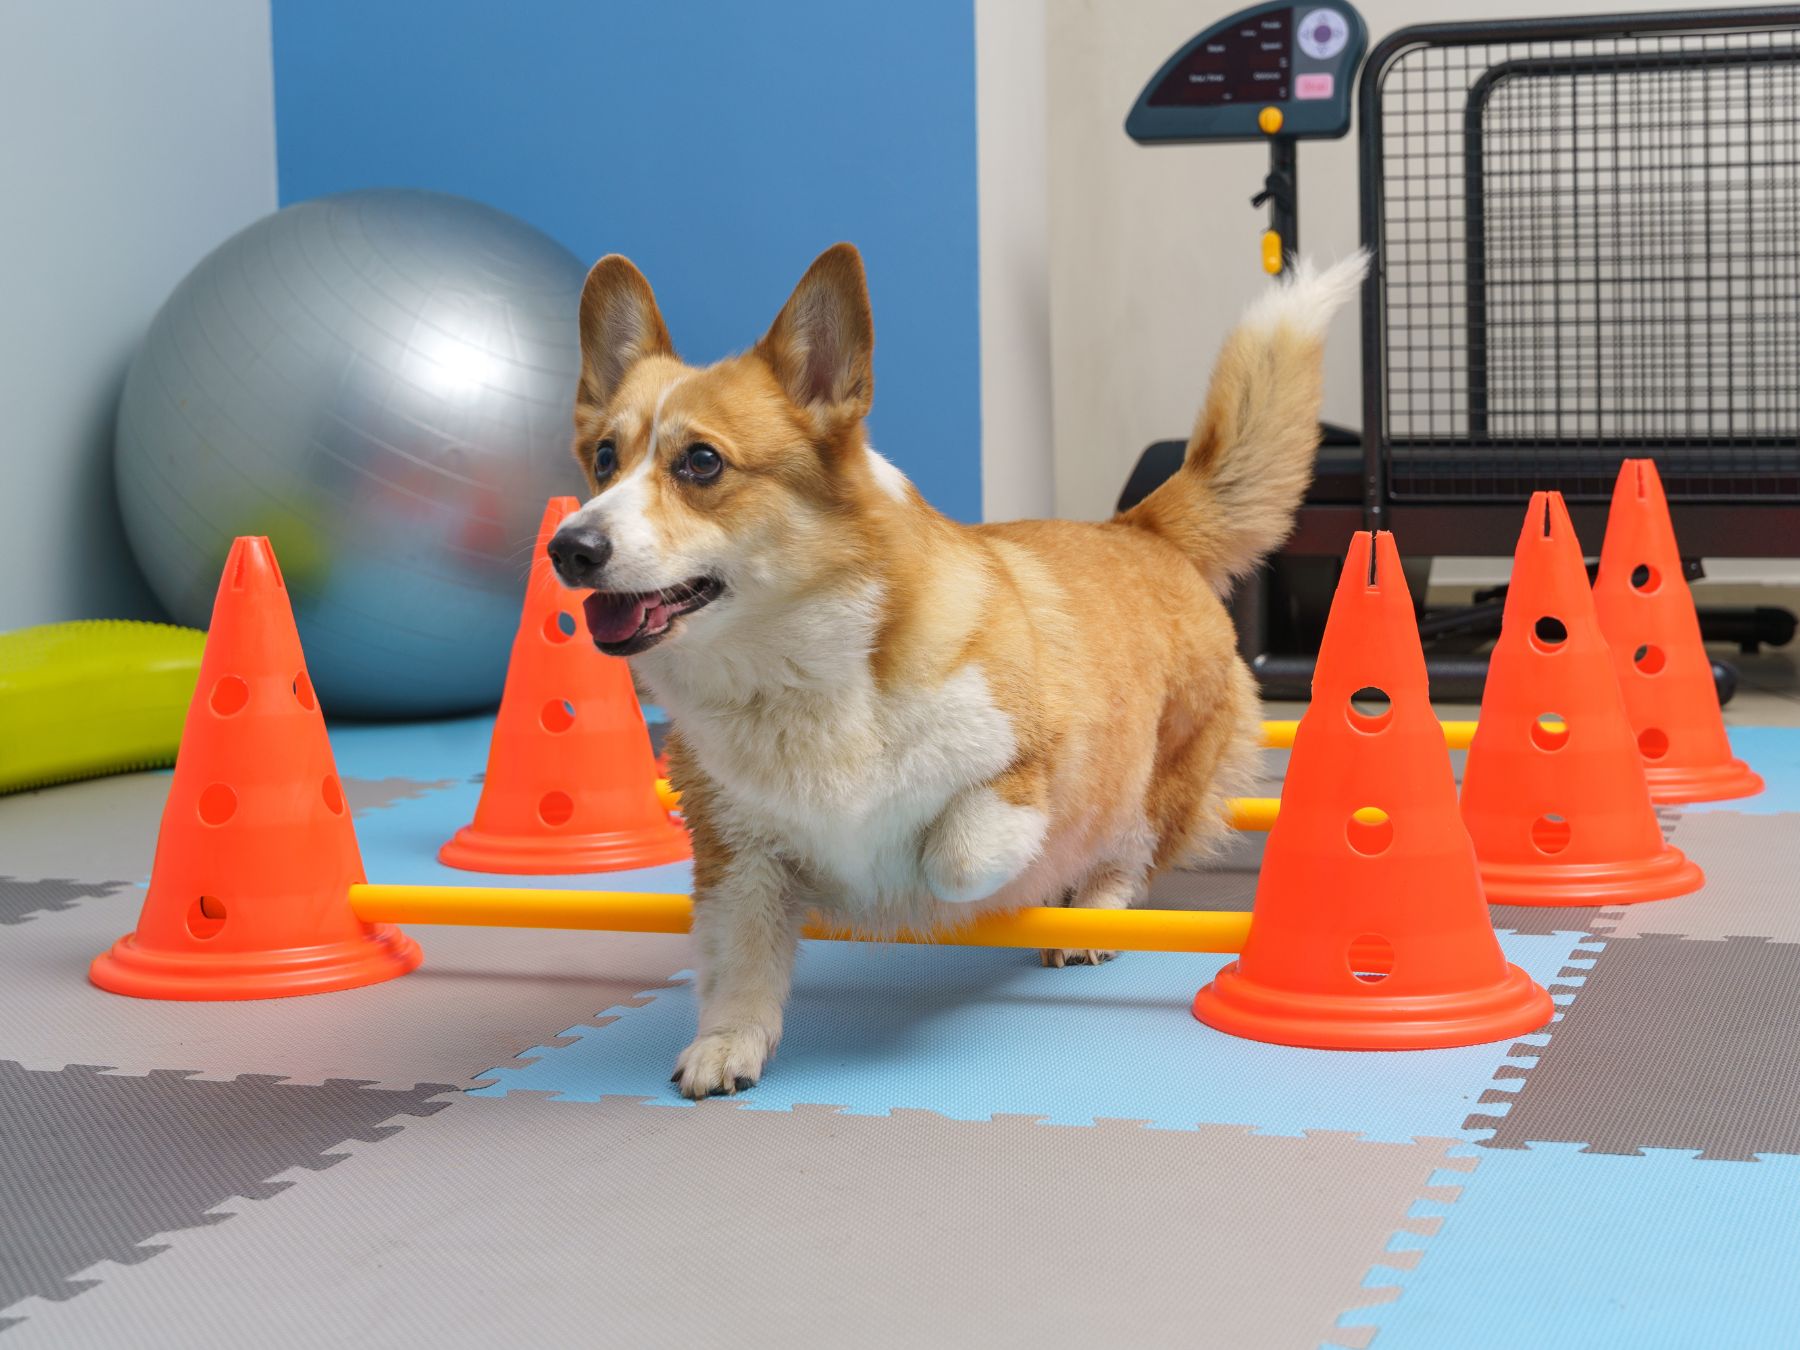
[0,772,169,882]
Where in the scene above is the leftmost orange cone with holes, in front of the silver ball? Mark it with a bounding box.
[88,538,419,999]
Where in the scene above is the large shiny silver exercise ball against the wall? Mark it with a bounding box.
[117,189,585,716]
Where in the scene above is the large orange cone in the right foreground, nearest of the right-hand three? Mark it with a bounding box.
[1193,533,1552,1049]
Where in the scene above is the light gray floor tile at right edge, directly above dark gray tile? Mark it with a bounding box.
[1595,810,1800,941]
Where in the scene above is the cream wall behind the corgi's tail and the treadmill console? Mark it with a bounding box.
[1051,0,1735,518]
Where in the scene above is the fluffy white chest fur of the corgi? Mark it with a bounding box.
[644,587,1017,916]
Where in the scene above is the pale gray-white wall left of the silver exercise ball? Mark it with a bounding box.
[0,0,275,630]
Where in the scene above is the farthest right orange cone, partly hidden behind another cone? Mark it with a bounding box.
[1593,459,1762,803]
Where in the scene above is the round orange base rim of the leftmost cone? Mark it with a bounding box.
[88,923,425,1003]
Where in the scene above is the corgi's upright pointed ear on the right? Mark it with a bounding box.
[756,243,875,425]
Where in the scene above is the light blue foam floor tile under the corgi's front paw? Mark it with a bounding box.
[477,934,1575,1141]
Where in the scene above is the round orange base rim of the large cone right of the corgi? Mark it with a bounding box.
[1193,961,1555,1049]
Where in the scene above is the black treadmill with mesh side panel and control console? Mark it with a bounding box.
[1120,0,1800,700]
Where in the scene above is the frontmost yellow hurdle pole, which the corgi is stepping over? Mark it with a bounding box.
[349,886,1249,952]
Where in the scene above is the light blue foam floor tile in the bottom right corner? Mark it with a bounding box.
[1339,1143,1800,1350]
